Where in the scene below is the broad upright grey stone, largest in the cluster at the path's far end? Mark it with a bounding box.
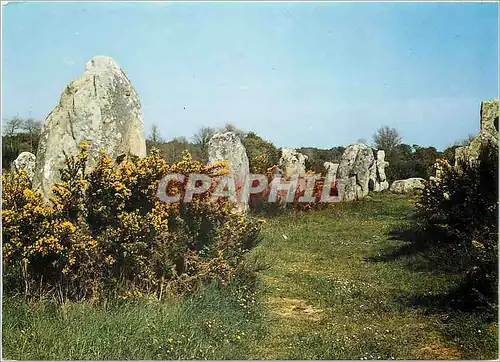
[337,143,375,201]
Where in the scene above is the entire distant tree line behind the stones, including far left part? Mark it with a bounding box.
[2,117,472,181]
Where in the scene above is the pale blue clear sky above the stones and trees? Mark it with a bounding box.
[2,2,498,149]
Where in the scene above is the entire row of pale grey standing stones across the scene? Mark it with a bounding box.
[10,56,498,210]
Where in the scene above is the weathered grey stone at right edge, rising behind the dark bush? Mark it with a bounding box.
[455,99,499,169]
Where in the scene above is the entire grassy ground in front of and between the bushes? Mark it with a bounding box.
[2,194,498,360]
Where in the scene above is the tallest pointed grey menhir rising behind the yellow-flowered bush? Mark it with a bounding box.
[33,56,146,199]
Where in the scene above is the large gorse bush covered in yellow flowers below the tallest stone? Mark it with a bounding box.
[2,144,260,300]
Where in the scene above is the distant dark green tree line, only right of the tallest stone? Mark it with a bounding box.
[146,123,472,181]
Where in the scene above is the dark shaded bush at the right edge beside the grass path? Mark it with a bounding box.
[416,146,498,299]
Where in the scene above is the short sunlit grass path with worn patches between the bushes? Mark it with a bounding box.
[254,196,480,359]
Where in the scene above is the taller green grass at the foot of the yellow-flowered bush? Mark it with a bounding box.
[3,283,264,360]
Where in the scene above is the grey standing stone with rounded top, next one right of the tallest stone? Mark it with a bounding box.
[208,132,250,212]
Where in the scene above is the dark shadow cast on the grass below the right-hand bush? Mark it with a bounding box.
[365,222,498,319]
